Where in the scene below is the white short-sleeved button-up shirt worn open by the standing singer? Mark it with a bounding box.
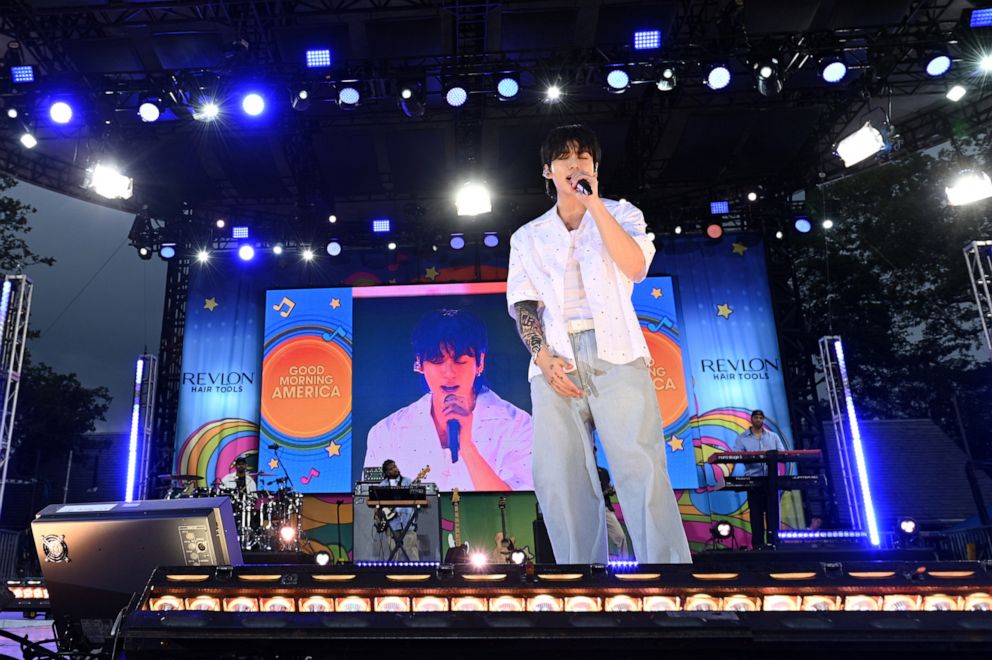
[506,199,655,380]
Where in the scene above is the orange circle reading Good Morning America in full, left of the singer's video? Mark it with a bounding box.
[262,336,351,438]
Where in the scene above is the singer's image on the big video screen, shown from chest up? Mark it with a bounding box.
[365,309,533,491]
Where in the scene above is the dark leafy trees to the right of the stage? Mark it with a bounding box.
[796,137,992,455]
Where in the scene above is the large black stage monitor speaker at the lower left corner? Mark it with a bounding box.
[31,497,242,649]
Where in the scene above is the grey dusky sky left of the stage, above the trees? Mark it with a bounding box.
[6,183,166,433]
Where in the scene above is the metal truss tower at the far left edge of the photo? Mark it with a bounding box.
[0,275,34,514]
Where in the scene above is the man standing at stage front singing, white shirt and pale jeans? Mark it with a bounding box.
[507,125,691,564]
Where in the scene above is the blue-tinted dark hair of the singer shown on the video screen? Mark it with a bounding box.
[412,309,489,394]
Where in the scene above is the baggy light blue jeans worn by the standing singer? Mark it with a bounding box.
[530,330,692,564]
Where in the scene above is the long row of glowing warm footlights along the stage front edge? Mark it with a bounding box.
[144,593,992,613]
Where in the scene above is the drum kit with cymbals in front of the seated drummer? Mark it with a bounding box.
[158,472,303,552]
